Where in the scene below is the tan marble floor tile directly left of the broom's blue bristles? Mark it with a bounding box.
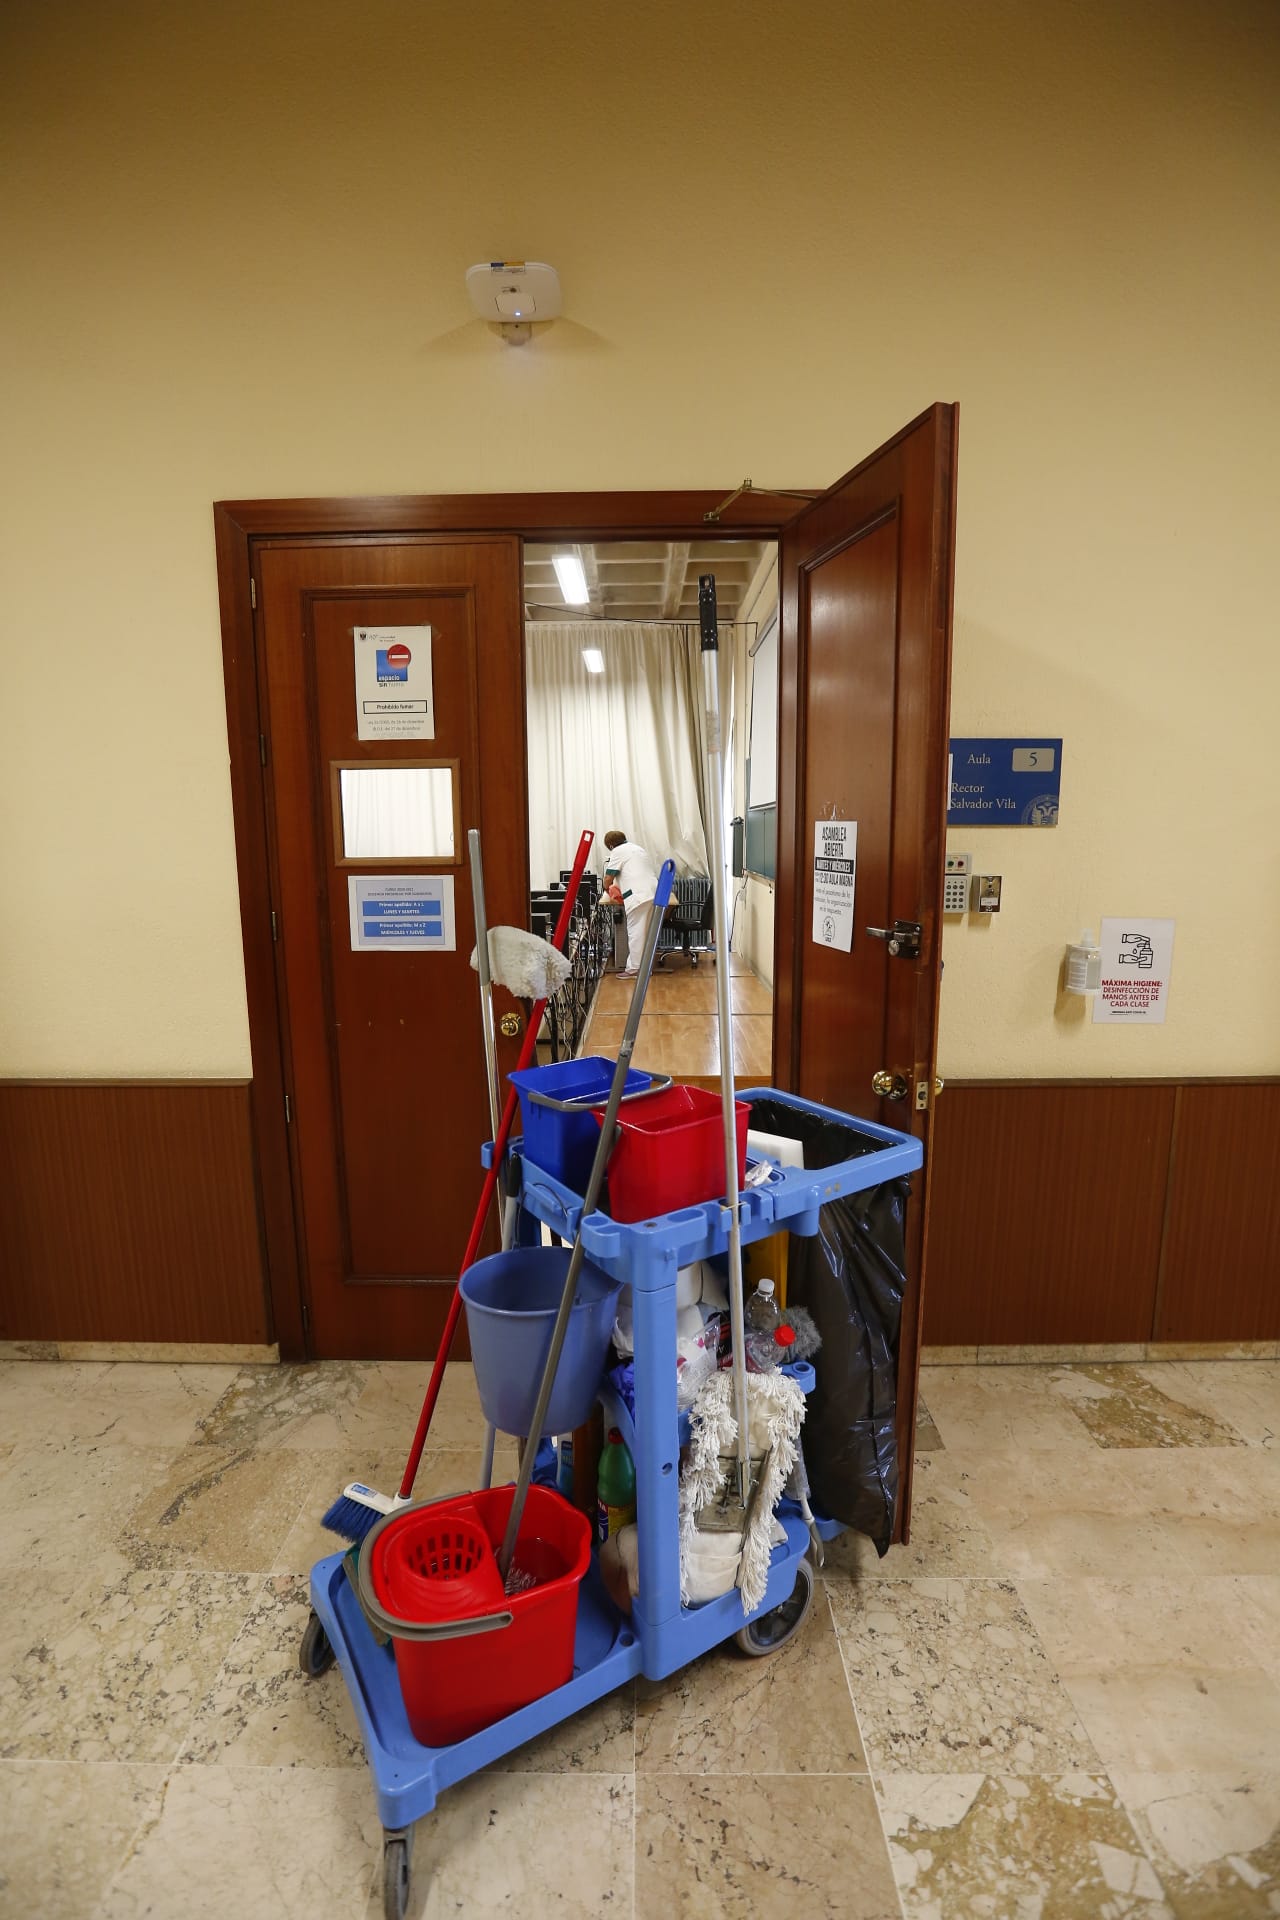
[117,1446,311,1572]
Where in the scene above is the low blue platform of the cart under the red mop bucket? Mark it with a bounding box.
[311,1553,641,1828]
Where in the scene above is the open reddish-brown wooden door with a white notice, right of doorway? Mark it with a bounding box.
[773,405,960,1538]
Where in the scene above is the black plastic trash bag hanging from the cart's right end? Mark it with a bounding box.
[750,1100,910,1555]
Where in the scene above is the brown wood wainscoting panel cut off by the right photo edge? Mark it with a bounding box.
[1151,1081,1280,1340]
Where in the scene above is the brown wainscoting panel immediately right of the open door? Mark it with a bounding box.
[923,1081,1176,1346]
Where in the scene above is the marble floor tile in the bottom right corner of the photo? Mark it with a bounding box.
[1111,1768,1280,1920]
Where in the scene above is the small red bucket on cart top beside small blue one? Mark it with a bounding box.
[597,1087,750,1221]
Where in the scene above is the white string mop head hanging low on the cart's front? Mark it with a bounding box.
[679,1371,804,1613]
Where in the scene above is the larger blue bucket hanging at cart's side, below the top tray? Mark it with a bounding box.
[459,1246,622,1438]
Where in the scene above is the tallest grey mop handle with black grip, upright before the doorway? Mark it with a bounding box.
[699,574,750,1507]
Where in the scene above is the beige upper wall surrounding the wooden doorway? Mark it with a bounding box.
[0,0,1280,1075]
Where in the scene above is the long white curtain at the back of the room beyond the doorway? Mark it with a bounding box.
[524,620,706,887]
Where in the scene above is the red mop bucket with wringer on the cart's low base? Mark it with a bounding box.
[368,1486,591,1747]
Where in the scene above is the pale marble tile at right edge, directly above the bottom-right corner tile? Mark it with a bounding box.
[1061,1665,1280,1772]
